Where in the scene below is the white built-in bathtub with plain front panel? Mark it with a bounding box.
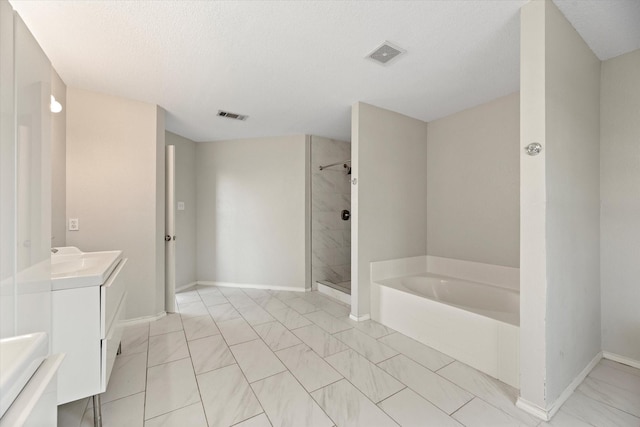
[371,259,520,388]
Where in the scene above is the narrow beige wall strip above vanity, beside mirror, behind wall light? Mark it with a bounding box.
[51,68,67,246]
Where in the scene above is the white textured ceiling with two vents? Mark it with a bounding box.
[11,0,640,141]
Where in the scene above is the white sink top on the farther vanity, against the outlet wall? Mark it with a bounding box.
[51,246,122,291]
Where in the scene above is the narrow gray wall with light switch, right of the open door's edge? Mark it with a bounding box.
[165,132,197,289]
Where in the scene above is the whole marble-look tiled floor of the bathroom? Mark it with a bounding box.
[58,287,640,427]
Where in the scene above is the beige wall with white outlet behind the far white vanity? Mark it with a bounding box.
[67,88,164,318]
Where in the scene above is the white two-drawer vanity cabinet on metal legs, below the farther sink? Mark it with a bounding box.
[52,251,127,405]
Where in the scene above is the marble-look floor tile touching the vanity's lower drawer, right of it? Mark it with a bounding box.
[101,353,147,403]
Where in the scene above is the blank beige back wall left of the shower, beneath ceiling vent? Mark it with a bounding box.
[196,135,308,289]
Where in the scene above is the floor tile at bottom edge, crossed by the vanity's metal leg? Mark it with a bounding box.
[81,393,144,427]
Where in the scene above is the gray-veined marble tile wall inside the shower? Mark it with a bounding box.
[311,136,351,283]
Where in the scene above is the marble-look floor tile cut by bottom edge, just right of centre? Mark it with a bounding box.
[311,380,398,427]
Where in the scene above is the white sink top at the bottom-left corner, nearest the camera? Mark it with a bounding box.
[0,332,49,417]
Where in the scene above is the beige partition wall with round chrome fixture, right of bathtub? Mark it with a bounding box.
[520,1,601,411]
